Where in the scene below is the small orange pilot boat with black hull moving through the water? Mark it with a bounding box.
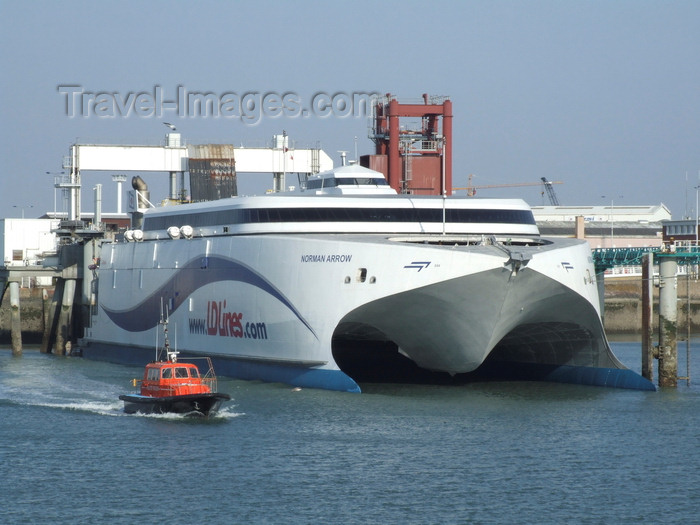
[119,310,231,416]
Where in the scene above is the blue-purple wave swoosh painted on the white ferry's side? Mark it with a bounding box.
[102,257,318,339]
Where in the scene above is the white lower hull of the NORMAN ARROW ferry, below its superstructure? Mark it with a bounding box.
[82,229,653,391]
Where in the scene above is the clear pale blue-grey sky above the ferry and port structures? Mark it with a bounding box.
[0,0,700,219]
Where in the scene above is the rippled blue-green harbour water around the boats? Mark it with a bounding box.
[0,340,700,524]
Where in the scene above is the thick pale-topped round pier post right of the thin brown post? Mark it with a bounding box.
[659,256,678,387]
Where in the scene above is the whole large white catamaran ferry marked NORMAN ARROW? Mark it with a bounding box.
[81,165,654,392]
